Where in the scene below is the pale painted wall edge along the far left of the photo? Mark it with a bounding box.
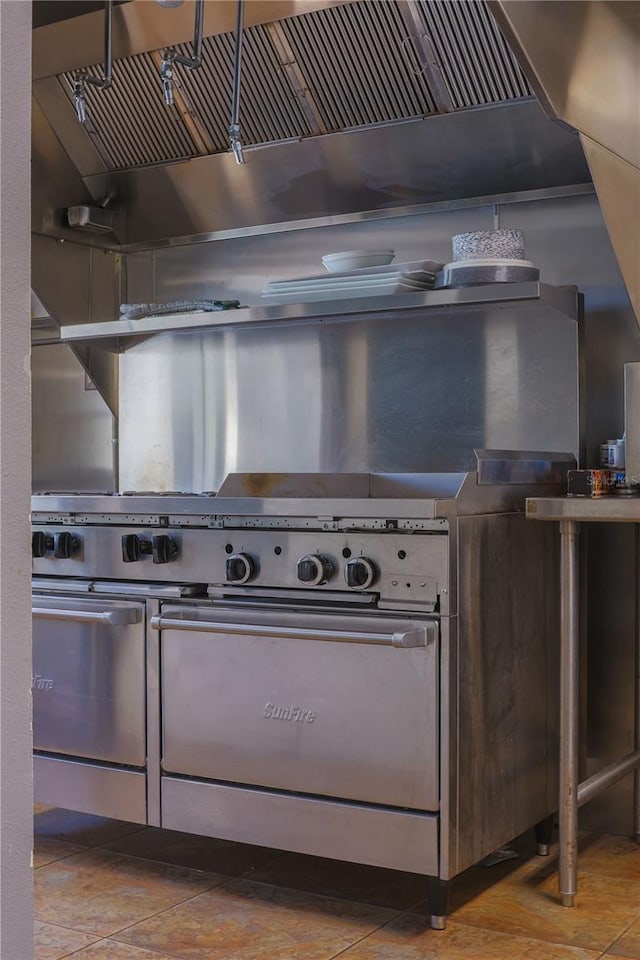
[0,0,33,960]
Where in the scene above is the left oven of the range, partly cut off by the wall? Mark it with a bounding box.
[32,584,147,822]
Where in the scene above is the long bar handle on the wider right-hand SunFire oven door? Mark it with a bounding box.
[151,616,427,647]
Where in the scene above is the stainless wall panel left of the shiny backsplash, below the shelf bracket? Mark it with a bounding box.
[31,344,116,492]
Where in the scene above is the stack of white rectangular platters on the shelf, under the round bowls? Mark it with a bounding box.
[262,260,442,303]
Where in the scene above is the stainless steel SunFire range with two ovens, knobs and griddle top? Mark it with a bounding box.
[33,451,573,927]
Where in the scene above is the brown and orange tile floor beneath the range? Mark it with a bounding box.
[34,807,640,960]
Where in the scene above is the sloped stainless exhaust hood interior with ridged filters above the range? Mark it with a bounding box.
[33,0,590,250]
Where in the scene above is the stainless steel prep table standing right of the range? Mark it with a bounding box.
[527,495,640,907]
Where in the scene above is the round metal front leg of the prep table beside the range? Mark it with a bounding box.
[558,520,580,907]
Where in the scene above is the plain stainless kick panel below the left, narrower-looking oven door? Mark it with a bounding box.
[33,755,147,823]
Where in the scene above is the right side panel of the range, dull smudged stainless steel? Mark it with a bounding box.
[440,515,559,877]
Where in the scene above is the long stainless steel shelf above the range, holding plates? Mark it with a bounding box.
[60,281,578,341]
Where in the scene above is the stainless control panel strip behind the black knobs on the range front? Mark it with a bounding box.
[33,517,449,622]
